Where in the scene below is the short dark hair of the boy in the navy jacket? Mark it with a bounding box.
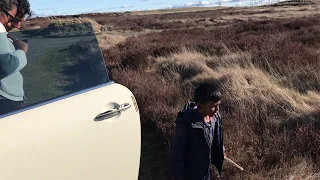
[193,83,221,104]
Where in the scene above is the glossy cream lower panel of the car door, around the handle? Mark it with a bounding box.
[0,83,141,180]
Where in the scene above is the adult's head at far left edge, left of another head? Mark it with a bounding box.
[0,0,18,27]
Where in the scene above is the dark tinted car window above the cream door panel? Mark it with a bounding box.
[0,23,109,115]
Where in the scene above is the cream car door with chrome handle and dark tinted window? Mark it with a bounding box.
[0,25,141,180]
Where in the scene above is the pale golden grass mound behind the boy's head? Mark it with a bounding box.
[152,49,320,115]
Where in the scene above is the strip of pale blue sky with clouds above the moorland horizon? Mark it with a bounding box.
[29,0,280,16]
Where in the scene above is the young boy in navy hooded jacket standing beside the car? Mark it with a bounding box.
[171,83,224,180]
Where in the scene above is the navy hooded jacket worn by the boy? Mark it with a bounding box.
[171,102,224,180]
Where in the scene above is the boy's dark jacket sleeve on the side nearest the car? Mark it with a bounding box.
[171,118,189,179]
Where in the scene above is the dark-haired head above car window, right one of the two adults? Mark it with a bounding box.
[5,0,31,32]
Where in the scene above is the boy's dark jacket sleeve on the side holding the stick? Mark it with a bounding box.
[211,114,224,174]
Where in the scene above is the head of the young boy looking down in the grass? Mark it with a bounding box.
[193,83,221,117]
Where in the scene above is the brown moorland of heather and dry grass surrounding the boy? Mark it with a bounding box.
[26,3,320,180]
